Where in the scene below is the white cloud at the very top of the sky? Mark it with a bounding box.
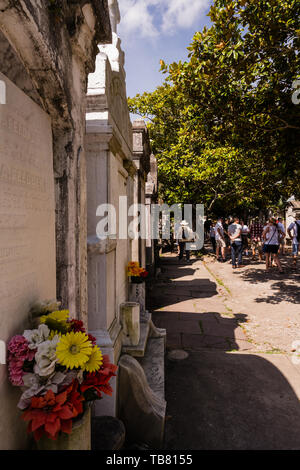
[119,0,210,38]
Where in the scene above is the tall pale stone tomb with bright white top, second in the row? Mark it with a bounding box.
[86,1,136,416]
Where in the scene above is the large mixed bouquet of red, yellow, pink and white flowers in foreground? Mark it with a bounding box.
[7,302,117,441]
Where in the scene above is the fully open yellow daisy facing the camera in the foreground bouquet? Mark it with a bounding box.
[56,331,93,369]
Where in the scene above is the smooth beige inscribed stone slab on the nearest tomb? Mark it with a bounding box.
[0,73,56,339]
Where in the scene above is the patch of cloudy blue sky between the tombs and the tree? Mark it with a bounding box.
[118,0,212,97]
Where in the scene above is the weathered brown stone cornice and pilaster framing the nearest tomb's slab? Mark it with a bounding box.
[0,0,111,319]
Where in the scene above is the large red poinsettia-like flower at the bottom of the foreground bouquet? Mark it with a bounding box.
[22,380,84,441]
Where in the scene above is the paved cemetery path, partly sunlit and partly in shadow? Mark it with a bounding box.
[148,254,300,450]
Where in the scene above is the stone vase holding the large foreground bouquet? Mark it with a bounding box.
[36,406,91,450]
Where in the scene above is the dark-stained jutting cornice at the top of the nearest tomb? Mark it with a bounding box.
[0,0,112,130]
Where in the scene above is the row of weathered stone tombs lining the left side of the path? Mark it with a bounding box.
[0,0,166,449]
